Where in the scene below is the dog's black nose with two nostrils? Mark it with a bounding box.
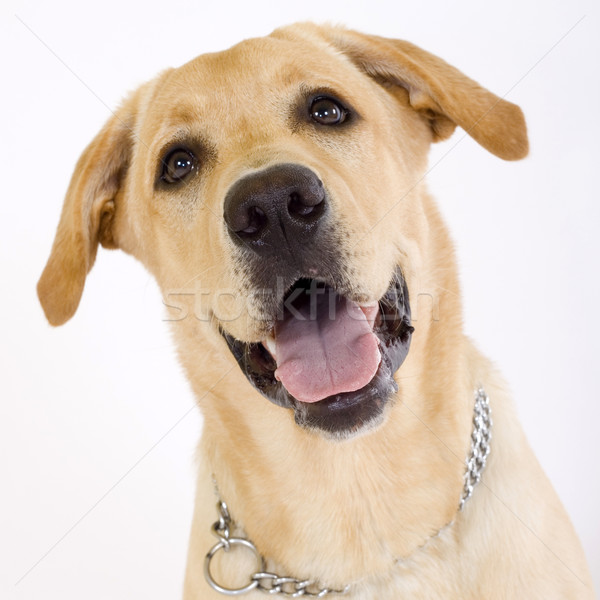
[224,164,327,255]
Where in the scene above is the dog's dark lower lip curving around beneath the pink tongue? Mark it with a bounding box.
[221,268,414,437]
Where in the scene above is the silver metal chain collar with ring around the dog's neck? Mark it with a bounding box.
[204,387,492,598]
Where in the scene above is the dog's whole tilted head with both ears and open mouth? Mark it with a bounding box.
[39,25,527,435]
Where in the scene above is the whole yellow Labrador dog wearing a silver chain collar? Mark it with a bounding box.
[38,23,593,600]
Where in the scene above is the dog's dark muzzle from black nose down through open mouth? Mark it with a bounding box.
[221,164,413,437]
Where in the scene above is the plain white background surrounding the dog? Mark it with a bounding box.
[0,0,600,600]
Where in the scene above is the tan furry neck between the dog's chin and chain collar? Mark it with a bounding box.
[203,360,480,584]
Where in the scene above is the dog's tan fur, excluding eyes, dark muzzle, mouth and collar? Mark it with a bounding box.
[38,24,593,600]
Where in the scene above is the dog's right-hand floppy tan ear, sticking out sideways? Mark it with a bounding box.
[330,29,529,160]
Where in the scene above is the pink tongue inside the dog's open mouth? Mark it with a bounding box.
[275,294,381,402]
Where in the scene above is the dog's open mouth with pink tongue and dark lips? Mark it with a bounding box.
[221,269,414,436]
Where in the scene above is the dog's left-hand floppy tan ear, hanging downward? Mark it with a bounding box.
[37,91,140,325]
